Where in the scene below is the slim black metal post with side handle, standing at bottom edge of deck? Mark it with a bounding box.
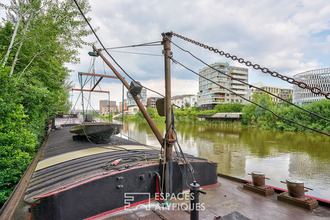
[190,181,206,220]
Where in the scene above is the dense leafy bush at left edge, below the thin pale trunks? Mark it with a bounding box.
[0,93,37,205]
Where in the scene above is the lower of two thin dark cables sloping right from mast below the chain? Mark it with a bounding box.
[168,56,330,136]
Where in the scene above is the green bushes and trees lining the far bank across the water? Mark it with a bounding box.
[124,99,330,133]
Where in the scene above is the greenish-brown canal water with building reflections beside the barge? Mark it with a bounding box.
[123,122,330,200]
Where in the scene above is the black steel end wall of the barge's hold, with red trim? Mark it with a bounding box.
[32,161,217,220]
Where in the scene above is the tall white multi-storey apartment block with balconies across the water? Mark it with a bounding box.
[197,62,249,110]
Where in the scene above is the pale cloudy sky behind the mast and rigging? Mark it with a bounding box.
[0,0,330,109]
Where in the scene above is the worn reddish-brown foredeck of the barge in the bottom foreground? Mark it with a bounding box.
[94,177,330,220]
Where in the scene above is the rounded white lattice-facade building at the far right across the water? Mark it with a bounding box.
[293,68,330,104]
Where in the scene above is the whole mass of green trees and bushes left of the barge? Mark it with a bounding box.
[0,0,90,206]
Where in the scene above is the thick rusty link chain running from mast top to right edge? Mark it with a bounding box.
[171,32,330,99]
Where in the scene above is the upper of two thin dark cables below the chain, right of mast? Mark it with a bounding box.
[171,41,330,122]
